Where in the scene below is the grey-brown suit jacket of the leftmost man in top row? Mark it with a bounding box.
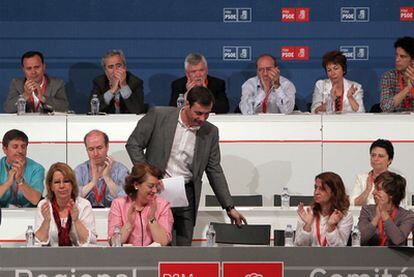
[4,76,69,113]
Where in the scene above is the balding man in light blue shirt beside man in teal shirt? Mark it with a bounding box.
[75,130,128,207]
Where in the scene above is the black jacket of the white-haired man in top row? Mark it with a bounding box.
[170,75,229,114]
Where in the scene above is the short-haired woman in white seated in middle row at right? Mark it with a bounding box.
[350,139,394,206]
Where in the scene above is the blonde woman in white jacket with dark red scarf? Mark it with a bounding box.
[35,163,97,246]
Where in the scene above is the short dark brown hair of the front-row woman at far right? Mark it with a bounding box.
[374,171,407,207]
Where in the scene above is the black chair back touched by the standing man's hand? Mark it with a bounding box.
[210,222,270,245]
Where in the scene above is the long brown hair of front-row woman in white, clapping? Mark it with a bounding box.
[311,172,349,215]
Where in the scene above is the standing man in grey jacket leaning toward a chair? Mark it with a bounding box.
[126,86,246,246]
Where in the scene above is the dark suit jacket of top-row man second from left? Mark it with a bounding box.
[89,71,144,114]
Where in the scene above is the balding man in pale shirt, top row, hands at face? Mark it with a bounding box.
[239,54,296,114]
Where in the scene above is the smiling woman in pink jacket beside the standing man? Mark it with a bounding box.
[108,164,174,246]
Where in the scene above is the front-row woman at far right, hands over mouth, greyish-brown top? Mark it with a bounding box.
[358,171,414,246]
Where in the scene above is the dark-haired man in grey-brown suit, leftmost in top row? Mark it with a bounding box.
[4,51,69,113]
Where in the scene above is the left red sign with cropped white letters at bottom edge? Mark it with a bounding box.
[158,262,220,277]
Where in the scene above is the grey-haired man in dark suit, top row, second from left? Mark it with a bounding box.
[90,50,144,114]
